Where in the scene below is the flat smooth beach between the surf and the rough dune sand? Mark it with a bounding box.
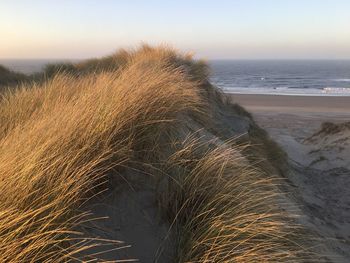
[229,94,350,154]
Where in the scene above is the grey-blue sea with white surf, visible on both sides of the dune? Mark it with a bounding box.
[0,59,350,96]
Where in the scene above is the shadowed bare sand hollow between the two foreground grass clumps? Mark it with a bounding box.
[78,170,175,262]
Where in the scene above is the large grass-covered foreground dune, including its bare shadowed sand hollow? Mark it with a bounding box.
[0,46,325,262]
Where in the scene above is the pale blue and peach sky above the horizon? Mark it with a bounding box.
[0,0,350,59]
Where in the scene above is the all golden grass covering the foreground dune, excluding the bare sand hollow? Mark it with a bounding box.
[0,46,318,262]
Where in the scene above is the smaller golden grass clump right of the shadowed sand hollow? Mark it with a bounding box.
[164,139,312,262]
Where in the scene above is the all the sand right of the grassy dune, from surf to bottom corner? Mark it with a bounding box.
[231,94,350,262]
